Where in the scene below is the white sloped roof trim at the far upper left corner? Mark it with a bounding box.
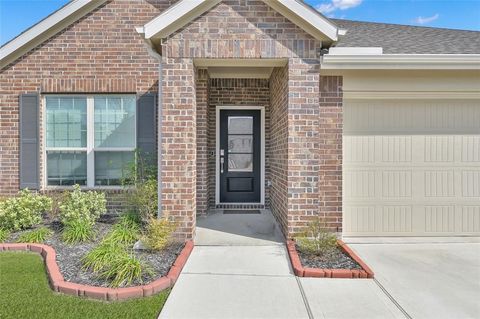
[0,0,106,68]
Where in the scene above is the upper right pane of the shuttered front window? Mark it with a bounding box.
[94,96,136,148]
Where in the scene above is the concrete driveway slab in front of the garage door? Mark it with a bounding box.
[349,243,480,319]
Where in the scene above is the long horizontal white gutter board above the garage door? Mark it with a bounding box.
[321,54,480,70]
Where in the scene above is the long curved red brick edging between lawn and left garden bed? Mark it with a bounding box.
[0,240,193,301]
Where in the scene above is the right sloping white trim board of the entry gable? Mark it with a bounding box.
[263,0,339,41]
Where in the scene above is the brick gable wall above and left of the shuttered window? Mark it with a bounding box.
[0,0,175,205]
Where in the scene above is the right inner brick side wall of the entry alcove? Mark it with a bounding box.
[269,66,288,234]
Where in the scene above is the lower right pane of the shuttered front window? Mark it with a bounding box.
[95,151,135,185]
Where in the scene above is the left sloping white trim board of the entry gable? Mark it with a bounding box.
[143,0,220,39]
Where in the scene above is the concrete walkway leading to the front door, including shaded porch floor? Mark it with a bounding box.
[159,211,405,319]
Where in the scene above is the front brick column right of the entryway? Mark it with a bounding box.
[288,58,320,236]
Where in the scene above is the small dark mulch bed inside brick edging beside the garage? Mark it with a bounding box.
[295,245,362,269]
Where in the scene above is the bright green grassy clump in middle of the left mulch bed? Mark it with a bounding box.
[82,241,127,273]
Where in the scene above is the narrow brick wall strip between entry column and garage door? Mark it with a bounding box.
[319,76,343,232]
